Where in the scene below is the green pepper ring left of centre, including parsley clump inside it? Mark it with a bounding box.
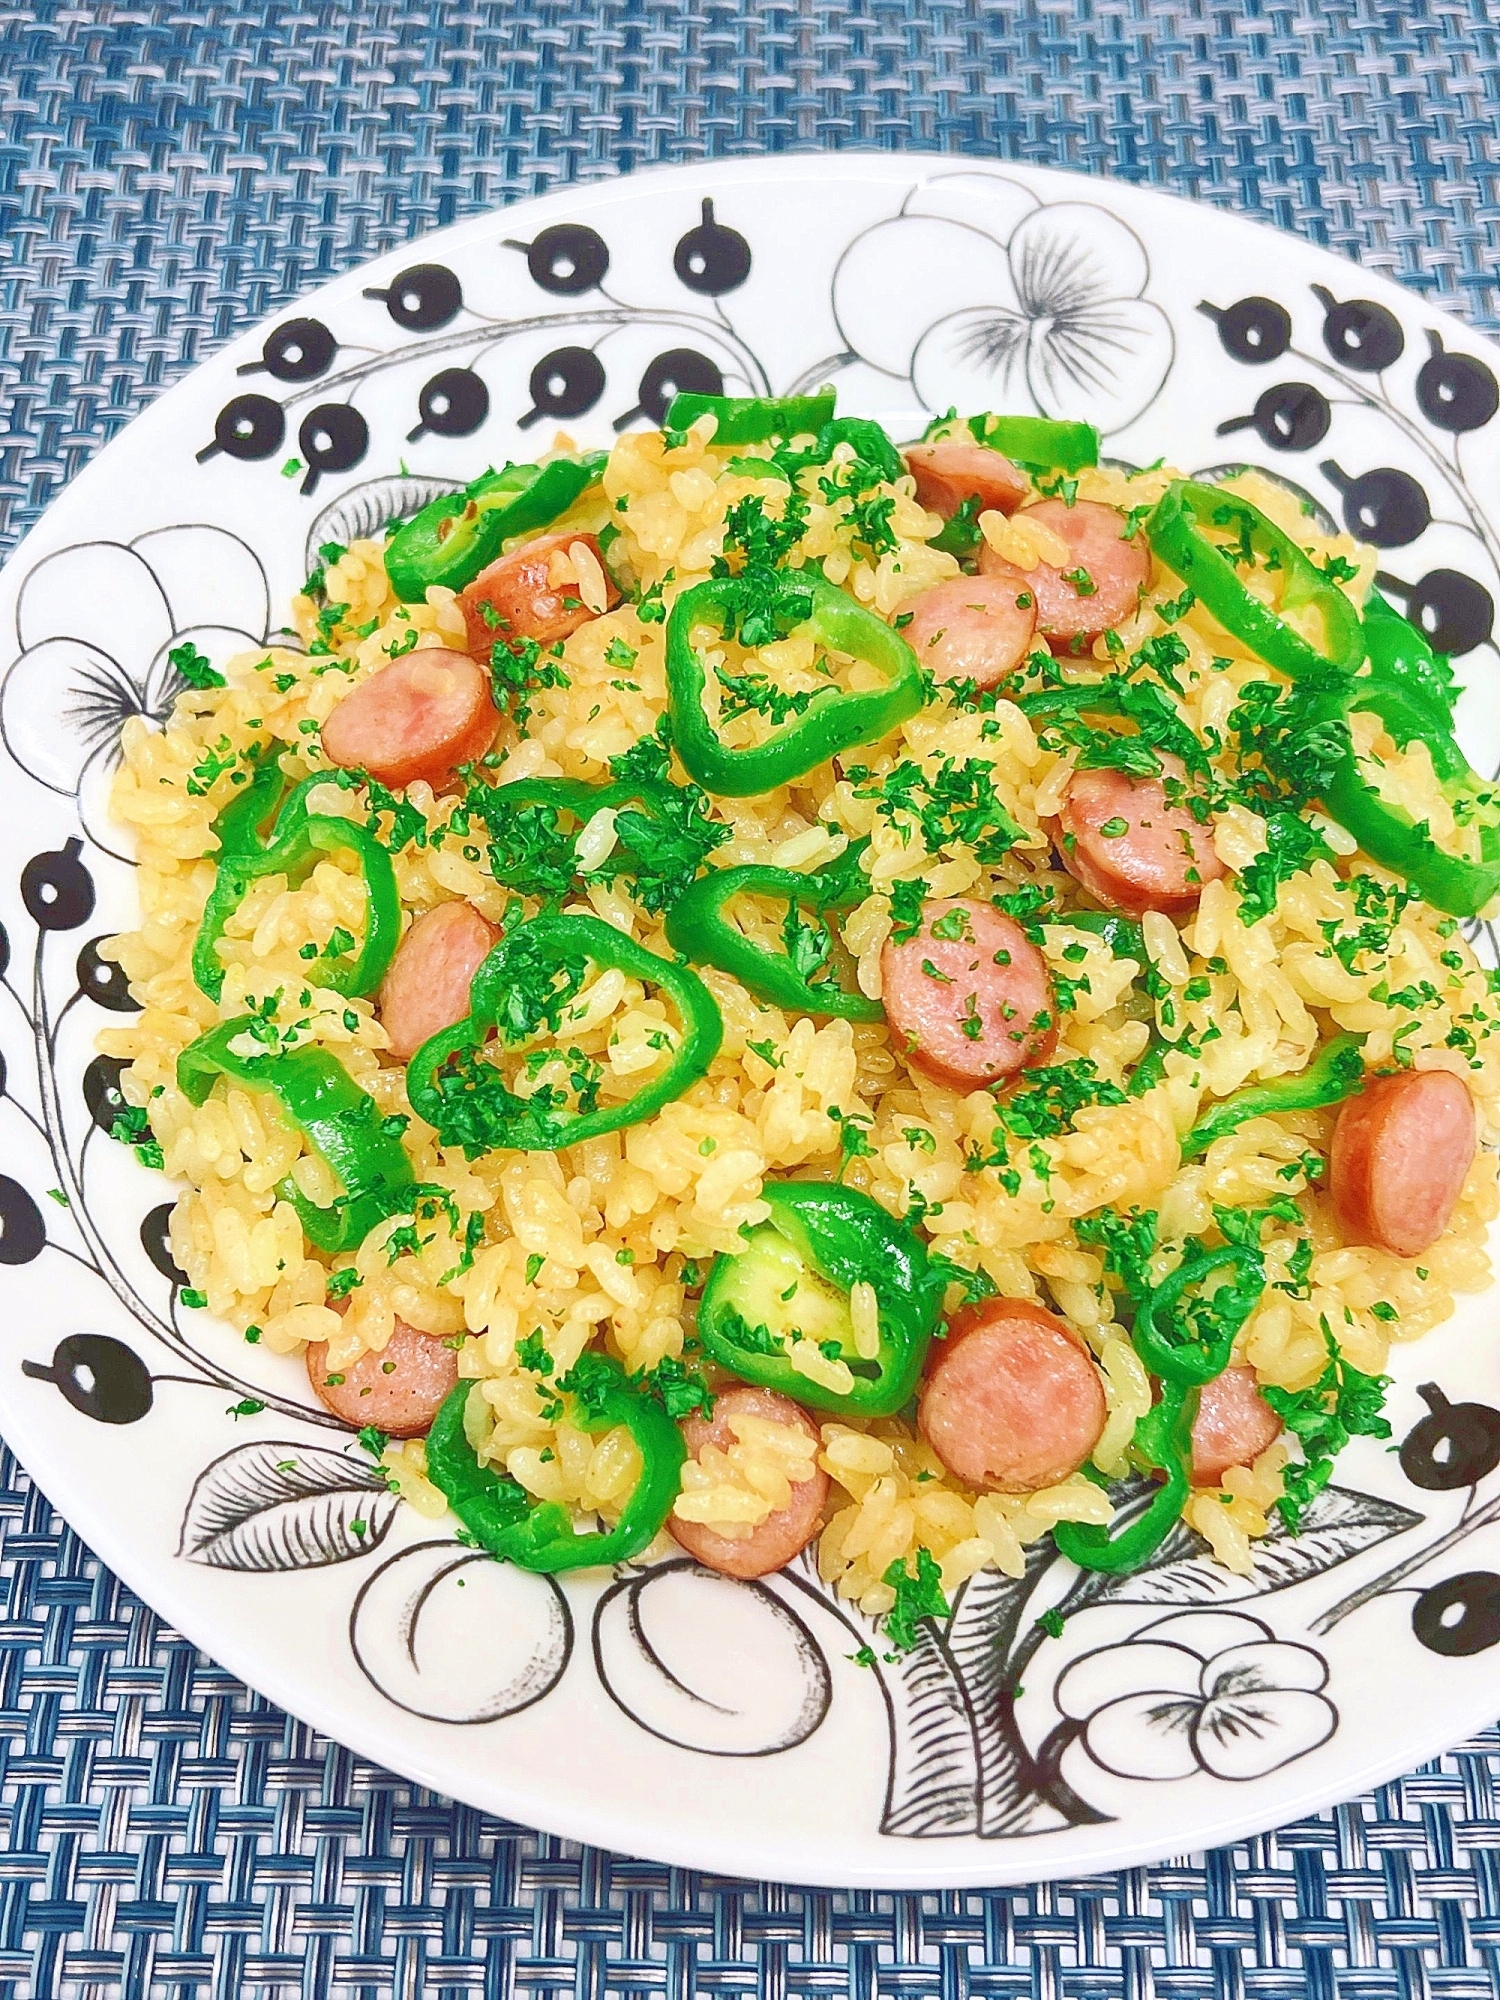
[406,912,724,1160]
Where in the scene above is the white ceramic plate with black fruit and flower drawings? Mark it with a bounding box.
[0,154,1500,1888]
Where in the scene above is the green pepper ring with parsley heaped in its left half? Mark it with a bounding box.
[406,910,724,1152]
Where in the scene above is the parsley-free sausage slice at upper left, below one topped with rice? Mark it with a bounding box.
[322,646,500,790]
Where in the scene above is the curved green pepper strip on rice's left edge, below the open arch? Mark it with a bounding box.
[178,1014,418,1250]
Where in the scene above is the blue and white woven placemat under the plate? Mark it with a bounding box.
[0,0,1500,2000]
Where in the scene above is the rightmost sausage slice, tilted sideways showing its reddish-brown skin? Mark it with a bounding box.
[1328,1070,1476,1256]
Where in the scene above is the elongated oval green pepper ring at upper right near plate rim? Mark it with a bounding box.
[1146,480,1364,680]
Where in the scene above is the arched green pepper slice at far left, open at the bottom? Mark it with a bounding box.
[192,764,402,1000]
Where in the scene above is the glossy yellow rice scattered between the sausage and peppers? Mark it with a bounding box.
[100,428,1500,1612]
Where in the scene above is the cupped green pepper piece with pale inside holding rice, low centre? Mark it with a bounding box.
[698,1180,946,1416]
